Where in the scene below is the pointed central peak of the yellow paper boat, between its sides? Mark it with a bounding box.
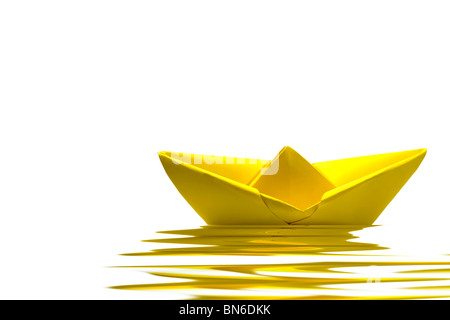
[249,147,334,210]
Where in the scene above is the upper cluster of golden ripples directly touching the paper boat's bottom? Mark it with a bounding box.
[124,225,387,256]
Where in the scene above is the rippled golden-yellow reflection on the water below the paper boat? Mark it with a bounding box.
[111,226,450,299]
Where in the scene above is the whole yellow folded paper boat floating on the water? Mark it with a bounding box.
[159,147,426,225]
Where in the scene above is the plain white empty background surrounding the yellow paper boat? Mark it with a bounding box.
[0,0,450,299]
